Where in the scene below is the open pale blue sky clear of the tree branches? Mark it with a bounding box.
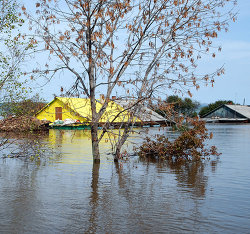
[21,0,250,105]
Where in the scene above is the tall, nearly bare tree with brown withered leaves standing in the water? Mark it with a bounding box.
[23,0,235,162]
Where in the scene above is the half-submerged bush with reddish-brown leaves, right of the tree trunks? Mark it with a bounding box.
[138,118,219,161]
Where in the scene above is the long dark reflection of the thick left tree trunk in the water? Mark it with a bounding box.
[86,163,100,233]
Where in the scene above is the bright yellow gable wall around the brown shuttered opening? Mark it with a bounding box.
[36,99,86,122]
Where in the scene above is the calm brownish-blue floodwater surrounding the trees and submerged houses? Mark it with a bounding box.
[0,125,250,233]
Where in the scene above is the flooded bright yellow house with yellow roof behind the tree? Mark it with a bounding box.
[36,97,141,123]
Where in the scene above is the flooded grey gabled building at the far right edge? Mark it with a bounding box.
[202,104,250,122]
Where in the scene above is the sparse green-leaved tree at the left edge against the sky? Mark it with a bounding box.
[0,0,29,106]
